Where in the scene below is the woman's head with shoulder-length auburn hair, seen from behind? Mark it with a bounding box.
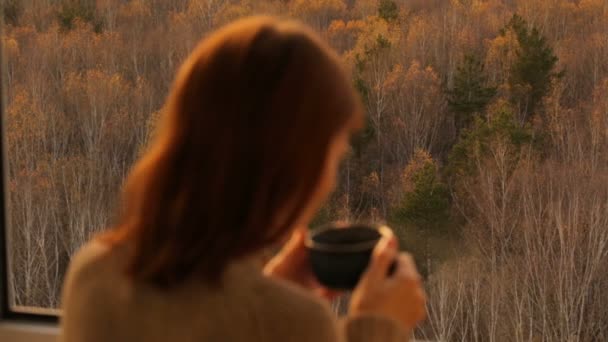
[110,17,363,286]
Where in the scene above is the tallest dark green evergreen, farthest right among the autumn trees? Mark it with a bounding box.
[501,14,563,119]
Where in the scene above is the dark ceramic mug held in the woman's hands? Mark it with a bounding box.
[306,224,396,290]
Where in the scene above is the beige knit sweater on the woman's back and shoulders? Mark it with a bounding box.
[59,242,408,342]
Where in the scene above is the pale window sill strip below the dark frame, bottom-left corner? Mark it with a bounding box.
[0,321,59,342]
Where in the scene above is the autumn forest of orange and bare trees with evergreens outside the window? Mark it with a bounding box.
[1,0,608,342]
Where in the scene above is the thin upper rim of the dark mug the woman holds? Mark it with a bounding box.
[304,223,391,253]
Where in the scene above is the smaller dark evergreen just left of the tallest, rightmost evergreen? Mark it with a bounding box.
[448,55,496,130]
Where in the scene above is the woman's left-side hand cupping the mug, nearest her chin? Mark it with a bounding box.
[264,228,340,300]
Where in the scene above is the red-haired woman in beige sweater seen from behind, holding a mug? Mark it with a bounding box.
[61,17,425,342]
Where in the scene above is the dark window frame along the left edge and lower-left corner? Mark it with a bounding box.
[0,18,60,326]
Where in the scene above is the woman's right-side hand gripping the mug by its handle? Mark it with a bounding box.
[349,232,426,331]
